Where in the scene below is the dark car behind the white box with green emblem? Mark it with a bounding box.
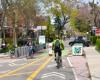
[69,36,90,47]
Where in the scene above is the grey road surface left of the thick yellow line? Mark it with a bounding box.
[0,49,50,80]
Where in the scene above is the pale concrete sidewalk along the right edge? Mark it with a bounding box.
[84,47,100,80]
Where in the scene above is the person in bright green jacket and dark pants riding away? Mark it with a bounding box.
[52,37,64,60]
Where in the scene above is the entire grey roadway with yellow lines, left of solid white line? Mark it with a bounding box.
[0,39,75,80]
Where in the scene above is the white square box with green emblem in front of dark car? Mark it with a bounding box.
[72,43,83,56]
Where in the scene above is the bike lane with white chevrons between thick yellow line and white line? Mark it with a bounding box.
[30,50,75,80]
